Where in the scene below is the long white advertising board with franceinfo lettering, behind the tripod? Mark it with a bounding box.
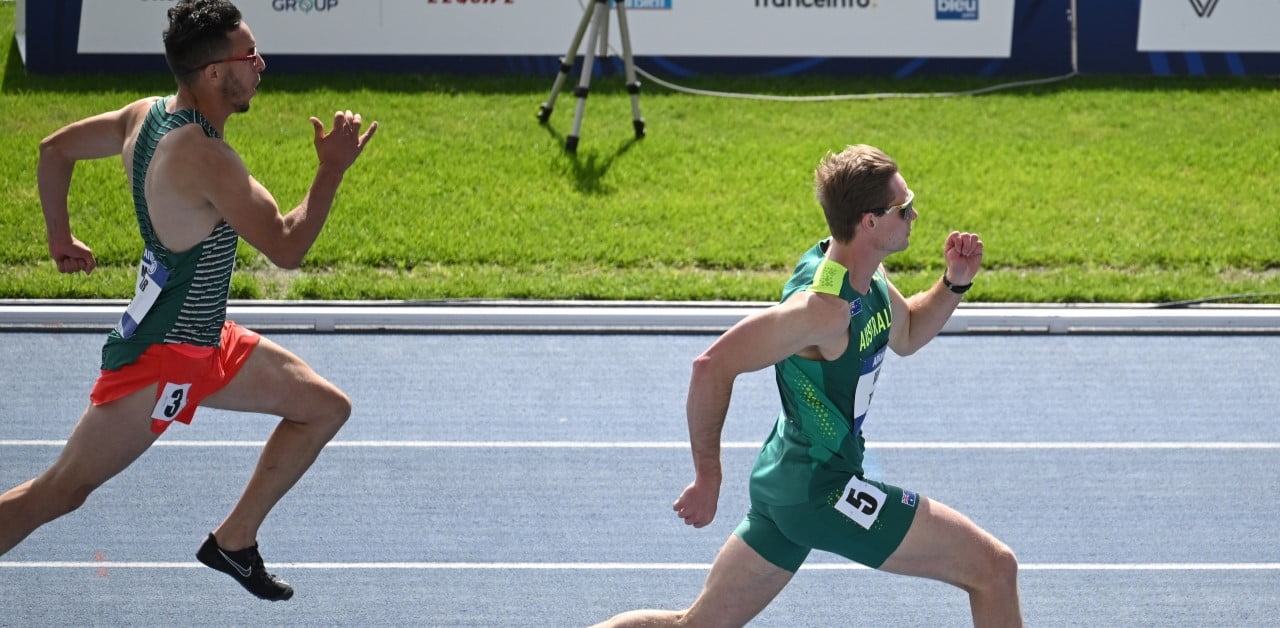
[78,0,1015,58]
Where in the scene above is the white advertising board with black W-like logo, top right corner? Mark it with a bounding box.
[1138,0,1280,52]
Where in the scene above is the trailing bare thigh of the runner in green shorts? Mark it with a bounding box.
[685,535,794,627]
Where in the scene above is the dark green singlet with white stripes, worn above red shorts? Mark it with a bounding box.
[102,96,239,371]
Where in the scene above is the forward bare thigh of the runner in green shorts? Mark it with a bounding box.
[881,498,1004,585]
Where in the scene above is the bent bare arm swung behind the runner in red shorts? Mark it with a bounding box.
[36,97,156,274]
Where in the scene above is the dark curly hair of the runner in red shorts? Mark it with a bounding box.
[164,0,241,83]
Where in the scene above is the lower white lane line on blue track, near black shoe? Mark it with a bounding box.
[0,560,1280,572]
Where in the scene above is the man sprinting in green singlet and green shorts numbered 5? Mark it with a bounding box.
[602,146,1021,627]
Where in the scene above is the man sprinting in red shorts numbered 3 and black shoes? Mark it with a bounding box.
[0,0,378,600]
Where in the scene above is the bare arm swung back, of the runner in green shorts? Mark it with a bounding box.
[672,290,849,528]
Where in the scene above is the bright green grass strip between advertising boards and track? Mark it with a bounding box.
[0,4,1280,303]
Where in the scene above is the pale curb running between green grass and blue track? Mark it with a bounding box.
[0,301,1280,334]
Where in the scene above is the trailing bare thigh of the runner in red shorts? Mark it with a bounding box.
[42,384,157,490]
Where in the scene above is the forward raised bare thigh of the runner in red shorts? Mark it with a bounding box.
[200,336,342,418]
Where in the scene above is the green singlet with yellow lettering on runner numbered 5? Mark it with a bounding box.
[751,239,892,505]
